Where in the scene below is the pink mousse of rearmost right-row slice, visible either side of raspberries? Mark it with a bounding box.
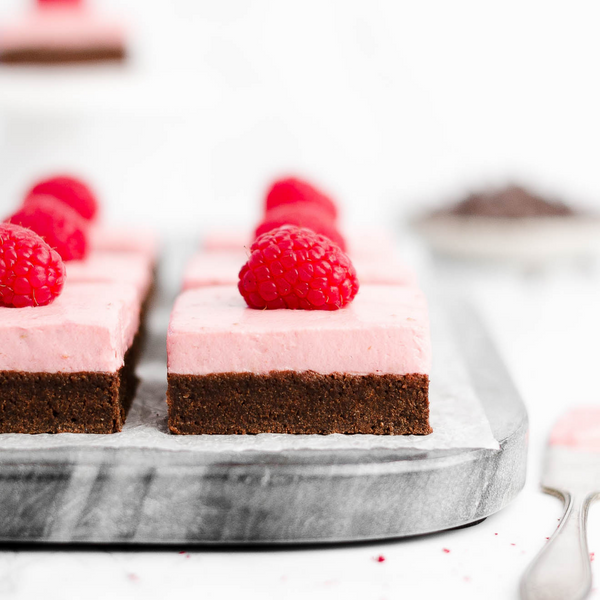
[202,229,395,260]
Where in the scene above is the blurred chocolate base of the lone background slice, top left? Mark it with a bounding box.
[0,47,126,64]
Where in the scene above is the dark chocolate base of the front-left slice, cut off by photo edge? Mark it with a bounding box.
[0,338,139,433]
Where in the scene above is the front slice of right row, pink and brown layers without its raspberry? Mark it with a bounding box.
[167,285,431,435]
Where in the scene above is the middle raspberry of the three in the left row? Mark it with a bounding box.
[6,196,88,260]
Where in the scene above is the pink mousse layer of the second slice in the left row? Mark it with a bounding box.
[65,252,153,303]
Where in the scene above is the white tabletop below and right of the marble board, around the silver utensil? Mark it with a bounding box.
[0,255,600,600]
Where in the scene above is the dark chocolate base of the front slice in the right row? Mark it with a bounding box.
[167,371,431,435]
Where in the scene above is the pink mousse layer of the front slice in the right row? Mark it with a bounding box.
[167,285,431,375]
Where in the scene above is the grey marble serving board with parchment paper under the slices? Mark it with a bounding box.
[0,246,527,544]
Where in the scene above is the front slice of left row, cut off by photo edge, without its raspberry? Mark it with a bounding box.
[0,282,140,433]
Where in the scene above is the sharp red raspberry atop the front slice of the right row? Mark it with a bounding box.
[238,225,359,310]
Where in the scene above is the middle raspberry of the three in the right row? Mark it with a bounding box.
[254,203,346,251]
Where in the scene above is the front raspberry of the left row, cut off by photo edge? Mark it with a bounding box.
[0,223,65,308]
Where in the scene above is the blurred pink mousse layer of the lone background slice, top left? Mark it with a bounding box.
[0,6,125,51]
